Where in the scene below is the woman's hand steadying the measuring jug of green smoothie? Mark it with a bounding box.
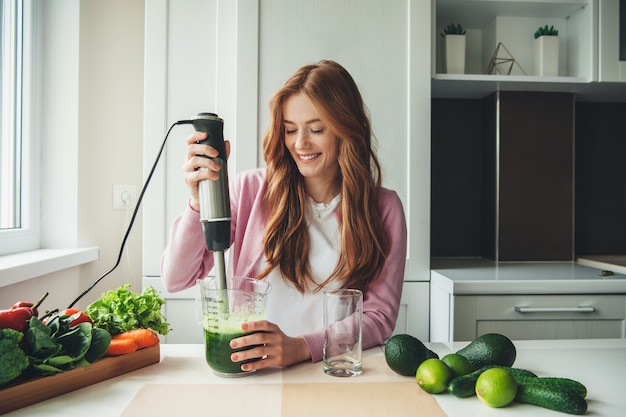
[230,320,311,371]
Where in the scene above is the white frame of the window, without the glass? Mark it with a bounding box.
[0,0,41,256]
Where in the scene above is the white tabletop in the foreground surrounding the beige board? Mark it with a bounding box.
[5,339,626,417]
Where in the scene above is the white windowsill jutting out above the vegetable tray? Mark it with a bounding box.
[0,246,100,287]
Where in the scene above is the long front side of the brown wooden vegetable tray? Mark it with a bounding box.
[0,345,161,414]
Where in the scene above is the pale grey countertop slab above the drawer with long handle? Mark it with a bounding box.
[430,258,626,295]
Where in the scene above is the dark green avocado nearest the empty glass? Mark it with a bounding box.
[385,334,428,376]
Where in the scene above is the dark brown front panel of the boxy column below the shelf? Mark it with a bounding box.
[498,92,574,261]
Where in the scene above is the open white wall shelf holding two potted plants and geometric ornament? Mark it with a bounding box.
[432,0,597,98]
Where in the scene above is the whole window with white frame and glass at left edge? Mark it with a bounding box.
[0,0,39,255]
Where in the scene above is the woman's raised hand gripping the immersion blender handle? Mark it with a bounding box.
[183,132,230,211]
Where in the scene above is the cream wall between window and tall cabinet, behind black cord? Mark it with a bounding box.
[0,0,144,309]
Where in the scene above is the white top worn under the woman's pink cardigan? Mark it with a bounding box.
[257,195,341,337]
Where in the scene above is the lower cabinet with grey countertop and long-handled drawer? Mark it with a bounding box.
[430,260,626,342]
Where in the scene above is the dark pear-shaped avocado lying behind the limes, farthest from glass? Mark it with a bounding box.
[456,333,517,369]
